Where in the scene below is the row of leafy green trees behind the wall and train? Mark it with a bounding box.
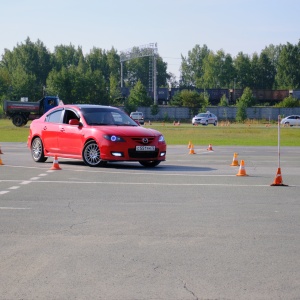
[0,37,300,110]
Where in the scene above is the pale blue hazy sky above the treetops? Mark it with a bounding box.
[0,0,300,79]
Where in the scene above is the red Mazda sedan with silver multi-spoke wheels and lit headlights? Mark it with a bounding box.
[27,104,167,167]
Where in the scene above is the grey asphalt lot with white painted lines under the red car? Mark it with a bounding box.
[0,143,300,300]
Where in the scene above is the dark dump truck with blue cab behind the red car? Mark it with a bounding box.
[3,96,60,127]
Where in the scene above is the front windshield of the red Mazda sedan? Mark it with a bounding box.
[81,107,138,126]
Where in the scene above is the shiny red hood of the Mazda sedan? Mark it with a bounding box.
[95,126,162,136]
